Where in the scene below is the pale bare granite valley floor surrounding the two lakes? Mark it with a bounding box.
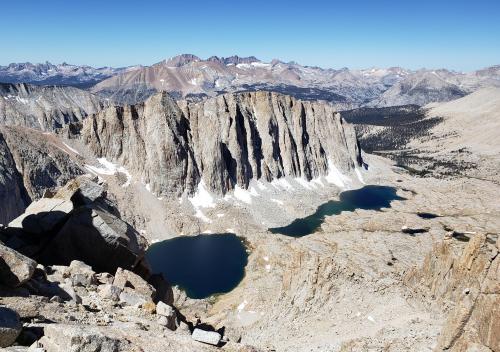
[99,155,500,351]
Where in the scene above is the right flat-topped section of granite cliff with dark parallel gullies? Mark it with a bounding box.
[184,92,361,193]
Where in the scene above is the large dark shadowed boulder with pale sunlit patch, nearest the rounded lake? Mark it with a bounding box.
[43,205,146,272]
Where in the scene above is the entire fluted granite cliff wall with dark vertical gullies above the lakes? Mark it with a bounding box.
[81,92,362,195]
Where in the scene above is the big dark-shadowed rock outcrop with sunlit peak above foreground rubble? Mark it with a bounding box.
[1,176,146,273]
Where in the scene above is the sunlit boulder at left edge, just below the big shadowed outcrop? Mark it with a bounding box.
[0,244,36,287]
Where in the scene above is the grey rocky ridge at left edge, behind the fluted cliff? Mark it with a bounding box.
[0,83,105,131]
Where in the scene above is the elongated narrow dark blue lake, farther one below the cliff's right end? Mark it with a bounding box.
[269,186,405,237]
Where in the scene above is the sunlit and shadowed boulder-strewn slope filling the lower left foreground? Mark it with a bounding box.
[0,176,257,352]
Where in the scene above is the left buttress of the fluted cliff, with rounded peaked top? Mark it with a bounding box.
[82,93,199,194]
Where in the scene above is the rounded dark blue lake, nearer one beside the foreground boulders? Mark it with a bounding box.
[146,233,248,298]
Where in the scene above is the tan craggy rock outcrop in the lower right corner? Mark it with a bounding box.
[405,234,500,352]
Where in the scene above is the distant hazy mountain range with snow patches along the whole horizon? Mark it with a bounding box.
[0,54,500,109]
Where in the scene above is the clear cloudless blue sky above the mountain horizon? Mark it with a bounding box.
[0,0,500,71]
